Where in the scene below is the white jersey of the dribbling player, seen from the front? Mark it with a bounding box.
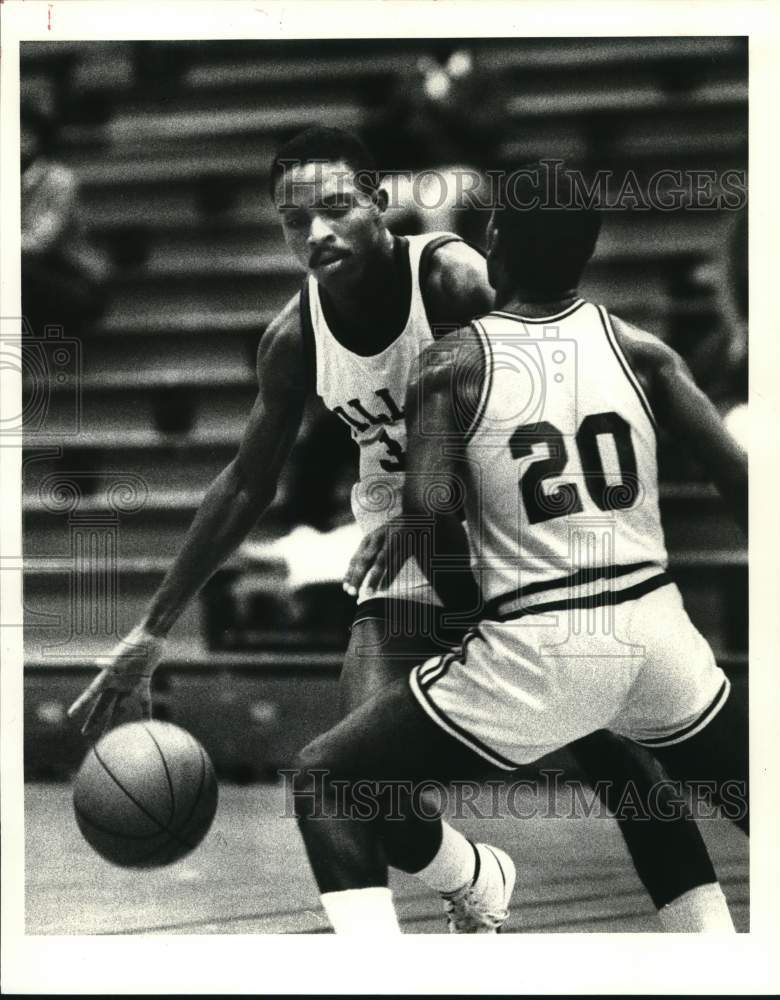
[307,233,458,603]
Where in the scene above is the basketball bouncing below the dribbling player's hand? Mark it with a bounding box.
[73,721,217,868]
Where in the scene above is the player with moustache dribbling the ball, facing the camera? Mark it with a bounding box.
[70,128,731,931]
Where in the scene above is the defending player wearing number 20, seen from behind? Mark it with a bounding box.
[288,166,748,931]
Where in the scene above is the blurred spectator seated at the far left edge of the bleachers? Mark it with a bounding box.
[20,97,109,333]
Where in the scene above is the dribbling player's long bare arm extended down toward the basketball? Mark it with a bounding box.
[69,296,306,734]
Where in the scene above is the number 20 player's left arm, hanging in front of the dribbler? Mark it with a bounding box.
[367,328,479,612]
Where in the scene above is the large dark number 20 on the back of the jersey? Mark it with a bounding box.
[509,410,639,524]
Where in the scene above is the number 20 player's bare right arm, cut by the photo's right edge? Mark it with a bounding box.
[611,316,748,532]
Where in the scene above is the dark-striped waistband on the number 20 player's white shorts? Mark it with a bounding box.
[483,561,672,621]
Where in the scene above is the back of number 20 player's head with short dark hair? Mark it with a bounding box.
[494,160,601,298]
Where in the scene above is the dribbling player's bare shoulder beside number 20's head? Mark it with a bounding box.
[422,238,493,325]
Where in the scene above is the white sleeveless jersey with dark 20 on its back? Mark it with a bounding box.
[465,299,667,617]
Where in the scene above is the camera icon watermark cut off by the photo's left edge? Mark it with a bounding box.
[0,317,83,444]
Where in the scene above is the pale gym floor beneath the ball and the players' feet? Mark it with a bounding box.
[25,783,748,935]
